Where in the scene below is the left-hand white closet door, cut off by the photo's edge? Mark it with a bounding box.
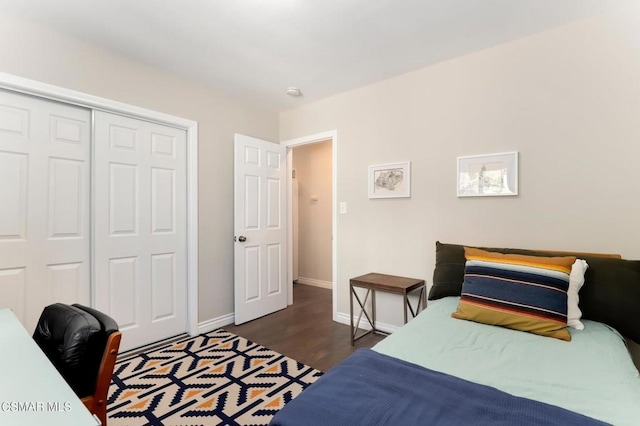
[0,90,91,332]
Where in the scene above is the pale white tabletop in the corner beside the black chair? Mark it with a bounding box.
[0,309,100,426]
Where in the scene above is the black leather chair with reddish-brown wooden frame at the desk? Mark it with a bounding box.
[33,303,122,425]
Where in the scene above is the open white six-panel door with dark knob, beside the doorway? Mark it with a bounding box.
[234,134,287,324]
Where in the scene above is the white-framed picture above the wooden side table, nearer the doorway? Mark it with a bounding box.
[369,161,411,198]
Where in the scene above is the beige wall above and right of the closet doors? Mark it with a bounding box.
[0,15,278,321]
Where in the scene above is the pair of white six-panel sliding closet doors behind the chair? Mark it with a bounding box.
[0,90,187,350]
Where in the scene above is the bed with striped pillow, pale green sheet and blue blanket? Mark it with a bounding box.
[271,242,640,426]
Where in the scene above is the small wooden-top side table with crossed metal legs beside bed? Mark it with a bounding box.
[349,273,427,346]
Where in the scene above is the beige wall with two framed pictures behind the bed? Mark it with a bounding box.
[280,11,640,325]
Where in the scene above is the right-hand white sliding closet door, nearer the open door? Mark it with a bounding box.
[93,111,187,350]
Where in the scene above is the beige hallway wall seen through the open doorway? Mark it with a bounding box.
[293,141,333,282]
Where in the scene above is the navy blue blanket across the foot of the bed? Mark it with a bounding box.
[270,349,605,426]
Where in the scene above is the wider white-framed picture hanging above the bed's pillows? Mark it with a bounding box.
[458,151,518,197]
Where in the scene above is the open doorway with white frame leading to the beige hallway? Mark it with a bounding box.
[282,131,337,321]
